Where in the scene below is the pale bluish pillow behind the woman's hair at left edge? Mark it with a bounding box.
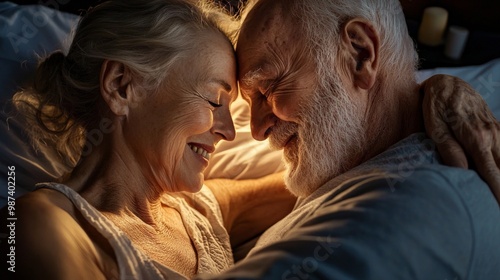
[0,2,78,207]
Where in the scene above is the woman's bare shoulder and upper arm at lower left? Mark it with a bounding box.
[0,189,114,279]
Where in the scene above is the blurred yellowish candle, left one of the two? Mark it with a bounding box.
[418,7,448,46]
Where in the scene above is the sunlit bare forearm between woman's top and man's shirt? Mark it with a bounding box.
[205,173,296,247]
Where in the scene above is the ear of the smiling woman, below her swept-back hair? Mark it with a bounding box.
[100,60,132,116]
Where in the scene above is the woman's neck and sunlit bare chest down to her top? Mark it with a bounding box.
[64,137,198,277]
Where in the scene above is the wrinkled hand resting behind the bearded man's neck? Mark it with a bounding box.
[421,75,500,203]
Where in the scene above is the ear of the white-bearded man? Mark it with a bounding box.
[341,18,380,89]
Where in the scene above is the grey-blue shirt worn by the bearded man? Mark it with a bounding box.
[202,134,500,280]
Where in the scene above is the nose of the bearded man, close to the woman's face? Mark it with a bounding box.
[250,102,277,141]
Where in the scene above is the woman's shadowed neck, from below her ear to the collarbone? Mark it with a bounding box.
[63,131,162,225]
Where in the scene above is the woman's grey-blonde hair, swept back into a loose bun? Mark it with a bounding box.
[13,0,234,165]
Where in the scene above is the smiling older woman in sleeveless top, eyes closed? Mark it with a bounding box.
[3,0,500,279]
